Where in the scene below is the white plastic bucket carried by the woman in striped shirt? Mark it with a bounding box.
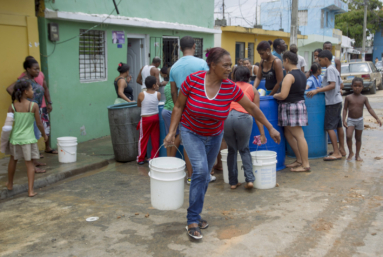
[149,157,186,210]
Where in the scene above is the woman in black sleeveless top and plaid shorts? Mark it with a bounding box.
[274,51,310,172]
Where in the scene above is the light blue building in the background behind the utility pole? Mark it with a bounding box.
[261,0,348,68]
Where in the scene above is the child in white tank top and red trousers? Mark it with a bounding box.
[137,76,161,165]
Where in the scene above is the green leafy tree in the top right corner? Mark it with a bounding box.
[335,0,383,47]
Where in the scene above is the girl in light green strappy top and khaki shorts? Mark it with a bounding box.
[7,81,48,197]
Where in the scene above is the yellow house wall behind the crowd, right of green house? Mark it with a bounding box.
[221,31,290,65]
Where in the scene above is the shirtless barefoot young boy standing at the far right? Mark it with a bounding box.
[343,78,382,161]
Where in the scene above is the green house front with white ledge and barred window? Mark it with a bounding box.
[39,0,216,147]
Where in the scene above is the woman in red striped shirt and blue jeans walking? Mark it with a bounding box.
[164,47,281,239]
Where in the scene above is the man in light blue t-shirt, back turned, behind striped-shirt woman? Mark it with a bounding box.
[169,36,216,184]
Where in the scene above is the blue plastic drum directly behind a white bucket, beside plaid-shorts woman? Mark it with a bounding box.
[249,96,286,170]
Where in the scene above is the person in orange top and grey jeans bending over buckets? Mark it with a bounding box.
[224,66,266,189]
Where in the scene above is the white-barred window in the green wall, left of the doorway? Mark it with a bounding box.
[79,29,106,81]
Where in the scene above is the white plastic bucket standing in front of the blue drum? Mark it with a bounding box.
[251,151,277,189]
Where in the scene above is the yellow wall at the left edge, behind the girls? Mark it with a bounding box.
[0,0,44,158]
